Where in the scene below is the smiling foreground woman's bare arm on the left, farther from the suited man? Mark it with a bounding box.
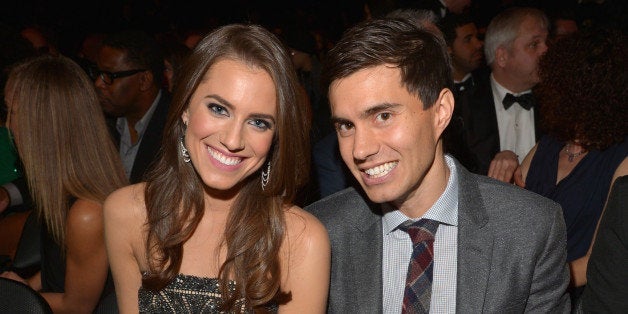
[104,185,145,313]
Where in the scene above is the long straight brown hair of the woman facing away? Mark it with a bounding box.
[7,56,128,248]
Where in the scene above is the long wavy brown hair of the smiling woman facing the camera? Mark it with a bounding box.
[143,24,309,312]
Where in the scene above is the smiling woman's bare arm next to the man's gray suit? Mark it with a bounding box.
[279,207,331,313]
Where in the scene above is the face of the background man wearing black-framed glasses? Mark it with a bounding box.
[94,46,143,117]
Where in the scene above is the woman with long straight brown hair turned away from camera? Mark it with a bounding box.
[3,56,126,313]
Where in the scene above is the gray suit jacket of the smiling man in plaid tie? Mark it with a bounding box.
[306,163,570,313]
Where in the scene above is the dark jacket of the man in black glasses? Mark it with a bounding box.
[107,91,170,184]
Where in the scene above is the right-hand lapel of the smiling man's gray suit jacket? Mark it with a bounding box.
[456,165,493,313]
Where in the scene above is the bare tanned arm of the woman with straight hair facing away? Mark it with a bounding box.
[42,199,109,313]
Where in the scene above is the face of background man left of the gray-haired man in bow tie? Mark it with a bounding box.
[450,23,484,74]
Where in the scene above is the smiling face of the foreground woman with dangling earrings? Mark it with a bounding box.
[181,59,277,191]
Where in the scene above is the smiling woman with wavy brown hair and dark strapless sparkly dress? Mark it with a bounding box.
[105,25,330,313]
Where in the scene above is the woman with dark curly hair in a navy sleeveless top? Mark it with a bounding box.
[522,29,628,287]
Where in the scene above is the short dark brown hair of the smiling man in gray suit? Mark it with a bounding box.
[324,18,453,109]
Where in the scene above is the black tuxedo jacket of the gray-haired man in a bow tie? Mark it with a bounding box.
[464,71,541,175]
